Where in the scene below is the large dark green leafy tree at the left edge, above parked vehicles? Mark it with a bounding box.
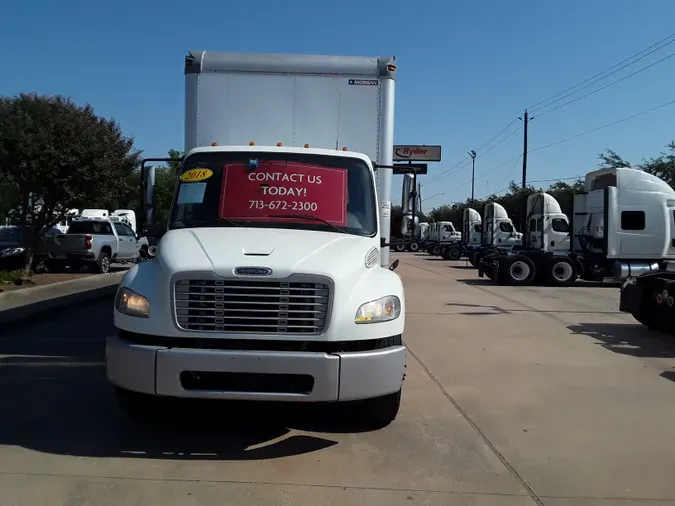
[0,94,140,268]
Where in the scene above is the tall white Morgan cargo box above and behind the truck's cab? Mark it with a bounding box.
[185,51,395,255]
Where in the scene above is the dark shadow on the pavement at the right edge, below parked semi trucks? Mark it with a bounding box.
[568,323,675,360]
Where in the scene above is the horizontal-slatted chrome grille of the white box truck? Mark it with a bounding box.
[174,279,329,334]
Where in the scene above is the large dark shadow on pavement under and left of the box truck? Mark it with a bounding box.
[0,300,386,460]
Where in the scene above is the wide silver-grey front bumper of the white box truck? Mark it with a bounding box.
[106,333,406,402]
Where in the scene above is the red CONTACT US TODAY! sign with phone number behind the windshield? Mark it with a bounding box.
[220,161,347,227]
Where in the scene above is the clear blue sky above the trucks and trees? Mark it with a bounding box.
[0,0,675,209]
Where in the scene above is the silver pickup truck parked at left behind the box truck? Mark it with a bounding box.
[37,217,141,273]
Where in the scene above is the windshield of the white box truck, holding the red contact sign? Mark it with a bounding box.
[169,151,377,237]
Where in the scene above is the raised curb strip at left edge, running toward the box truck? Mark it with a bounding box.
[0,270,126,326]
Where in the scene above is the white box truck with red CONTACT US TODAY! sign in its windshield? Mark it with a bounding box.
[106,51,406,425]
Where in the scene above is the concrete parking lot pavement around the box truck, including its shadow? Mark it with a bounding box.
[0,253,675,506]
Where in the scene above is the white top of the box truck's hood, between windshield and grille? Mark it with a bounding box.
[157,227,378,278]
